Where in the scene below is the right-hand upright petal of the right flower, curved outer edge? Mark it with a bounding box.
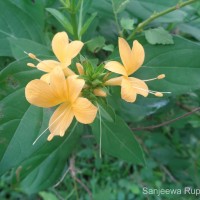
[128,40,145,75]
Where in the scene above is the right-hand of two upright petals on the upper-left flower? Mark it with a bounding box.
[66,40,83,59]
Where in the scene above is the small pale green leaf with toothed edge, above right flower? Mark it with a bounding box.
[144,27,174,44]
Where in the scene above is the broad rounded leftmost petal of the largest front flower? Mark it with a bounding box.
[25,79,62,108]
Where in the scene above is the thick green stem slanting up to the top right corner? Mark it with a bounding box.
[128,0,197,40]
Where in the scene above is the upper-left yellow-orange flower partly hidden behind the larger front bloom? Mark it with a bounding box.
[28,32,83,82]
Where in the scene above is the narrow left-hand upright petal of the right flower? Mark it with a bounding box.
[118,37,133,72]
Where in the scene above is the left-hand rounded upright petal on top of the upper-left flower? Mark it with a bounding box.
[51,32,69,62]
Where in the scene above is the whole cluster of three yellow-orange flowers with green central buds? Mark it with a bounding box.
[25,32,165,141]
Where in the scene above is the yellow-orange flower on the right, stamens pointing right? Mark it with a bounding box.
[105,38,164,102]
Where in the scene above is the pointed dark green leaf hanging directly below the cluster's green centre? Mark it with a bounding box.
[91,116,145,164]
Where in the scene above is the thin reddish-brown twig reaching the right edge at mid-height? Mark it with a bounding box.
[132,107,200,131]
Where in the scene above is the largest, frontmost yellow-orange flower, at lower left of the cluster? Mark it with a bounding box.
[25,67,97,141]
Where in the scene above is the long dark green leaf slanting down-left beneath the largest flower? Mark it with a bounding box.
[15,119,83,194]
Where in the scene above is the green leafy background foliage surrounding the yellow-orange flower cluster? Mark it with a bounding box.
[0,0,200,200]
